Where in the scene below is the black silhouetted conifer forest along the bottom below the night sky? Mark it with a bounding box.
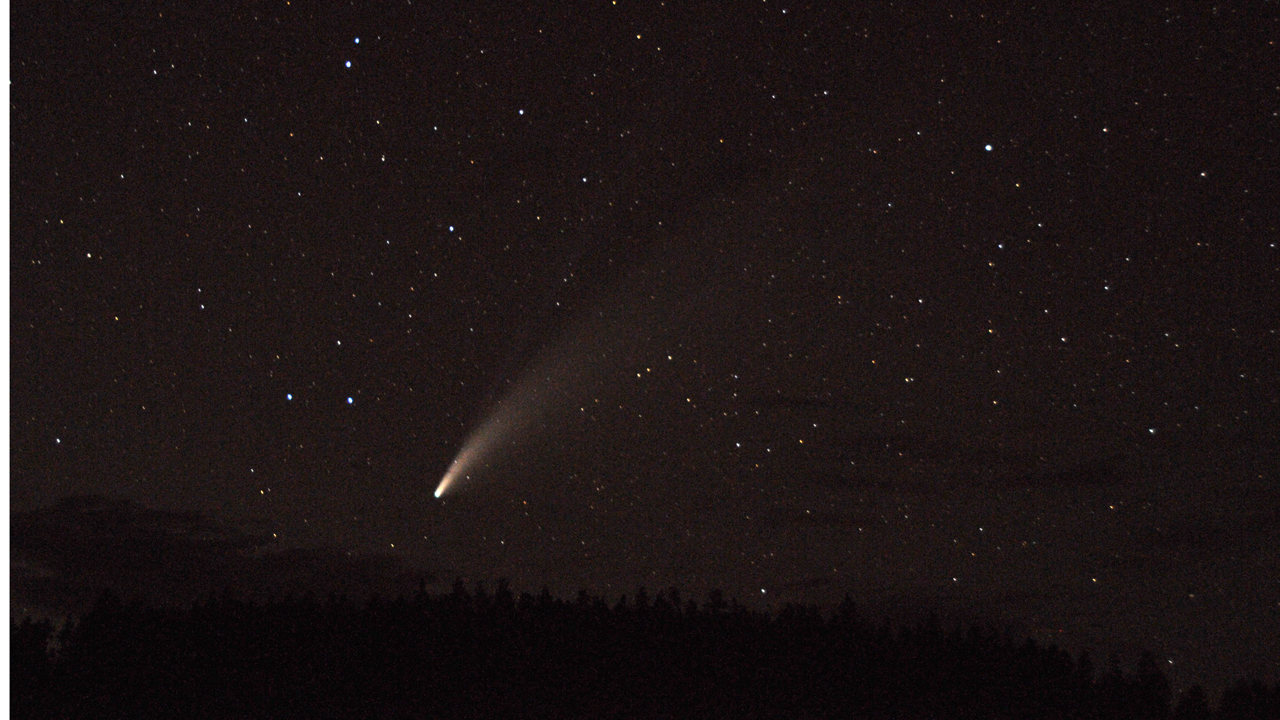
[10,580,1280,720]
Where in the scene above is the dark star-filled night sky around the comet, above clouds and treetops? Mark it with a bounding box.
[10,0,1280,684]
